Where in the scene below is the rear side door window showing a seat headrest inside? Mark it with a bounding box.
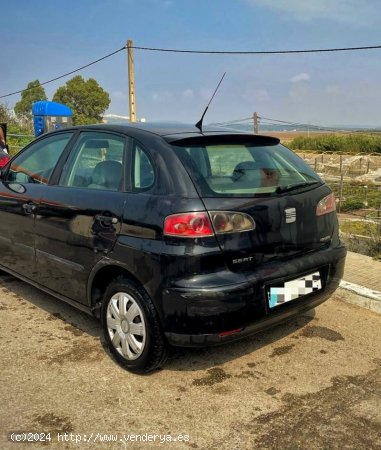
[59,131,125,191]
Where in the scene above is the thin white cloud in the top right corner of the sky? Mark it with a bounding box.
[247,0,381,27]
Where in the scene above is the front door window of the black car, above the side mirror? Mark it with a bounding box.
[5,133,73,184]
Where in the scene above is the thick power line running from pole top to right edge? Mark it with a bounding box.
[132,45,381,55]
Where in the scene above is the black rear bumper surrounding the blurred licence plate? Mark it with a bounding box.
[163,247,346,347]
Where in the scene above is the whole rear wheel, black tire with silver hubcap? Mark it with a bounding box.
[101,276,167,373]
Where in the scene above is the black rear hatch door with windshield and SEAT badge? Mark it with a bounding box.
[172,135,337,271]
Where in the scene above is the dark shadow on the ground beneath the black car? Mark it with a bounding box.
[0,272,315,376]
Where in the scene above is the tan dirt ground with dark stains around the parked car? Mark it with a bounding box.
[0,274,381,450]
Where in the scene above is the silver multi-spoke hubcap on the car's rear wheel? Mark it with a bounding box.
[107,292,147,360]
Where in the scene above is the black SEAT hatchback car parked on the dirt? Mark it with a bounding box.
[0,125,346,372]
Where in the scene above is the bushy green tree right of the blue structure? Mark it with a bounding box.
[53,75,111,125]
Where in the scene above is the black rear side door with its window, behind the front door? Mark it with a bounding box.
[35,131,129,304]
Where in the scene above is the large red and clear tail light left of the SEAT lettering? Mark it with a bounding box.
[164,211,255,237]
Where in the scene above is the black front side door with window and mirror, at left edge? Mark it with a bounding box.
[0,132,73,281]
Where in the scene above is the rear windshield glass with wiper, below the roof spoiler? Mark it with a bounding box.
[173,138,322,197]
